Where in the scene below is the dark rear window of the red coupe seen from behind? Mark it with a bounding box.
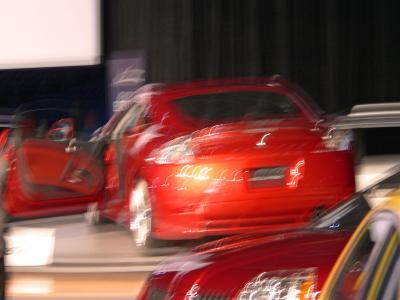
[174,91,298,121]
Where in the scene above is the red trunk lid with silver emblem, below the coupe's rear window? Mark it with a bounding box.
[191,120,322,157]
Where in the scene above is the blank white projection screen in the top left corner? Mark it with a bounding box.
[0,0,101,69]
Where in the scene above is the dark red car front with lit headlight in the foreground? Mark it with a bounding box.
[139,168,400,300]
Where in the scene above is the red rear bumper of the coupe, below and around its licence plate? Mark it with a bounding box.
[143,152,354,239]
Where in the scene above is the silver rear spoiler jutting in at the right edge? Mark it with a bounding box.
[331,102,400,131]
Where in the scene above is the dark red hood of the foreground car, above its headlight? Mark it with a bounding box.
[150,230,350,299]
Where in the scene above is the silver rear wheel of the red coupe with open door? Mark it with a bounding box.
[129,180,162,249]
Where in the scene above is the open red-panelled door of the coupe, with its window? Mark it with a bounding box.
[10,108,103,214]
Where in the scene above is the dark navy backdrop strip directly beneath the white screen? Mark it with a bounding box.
[0,65,107,125]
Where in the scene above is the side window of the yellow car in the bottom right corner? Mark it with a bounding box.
[332,213,394,300]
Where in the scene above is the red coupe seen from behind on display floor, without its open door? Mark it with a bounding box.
[87,76,354,246]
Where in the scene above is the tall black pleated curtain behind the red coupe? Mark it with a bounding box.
[104,0,400,112]
